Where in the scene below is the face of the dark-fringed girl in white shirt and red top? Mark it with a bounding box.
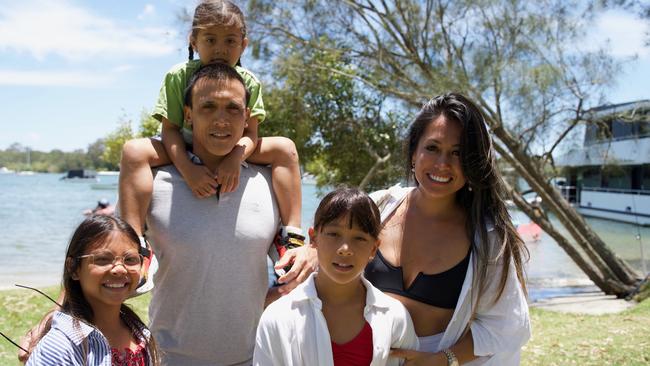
[309,216,378,285]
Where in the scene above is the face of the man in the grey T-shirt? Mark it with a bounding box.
[185,78,250,166]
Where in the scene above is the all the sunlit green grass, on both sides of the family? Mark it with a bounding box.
[0,287,650,366]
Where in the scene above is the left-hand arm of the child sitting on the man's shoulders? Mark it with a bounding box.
[162,118,217,198]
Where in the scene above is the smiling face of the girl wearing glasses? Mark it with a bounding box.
[73,231,140,311]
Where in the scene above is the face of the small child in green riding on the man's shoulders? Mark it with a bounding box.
[190,25,248,66]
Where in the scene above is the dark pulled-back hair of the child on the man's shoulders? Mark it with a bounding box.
[187,0,246,66]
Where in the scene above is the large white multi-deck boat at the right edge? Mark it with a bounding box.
[555,100,650,226]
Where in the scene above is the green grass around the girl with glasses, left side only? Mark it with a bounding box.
[0,286,151,366]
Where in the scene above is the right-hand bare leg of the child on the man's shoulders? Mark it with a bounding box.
[248,137,302,228]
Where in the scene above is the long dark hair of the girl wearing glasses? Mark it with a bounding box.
[61,215,159,365]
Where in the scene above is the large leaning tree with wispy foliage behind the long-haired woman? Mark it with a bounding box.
[248,0,639,296]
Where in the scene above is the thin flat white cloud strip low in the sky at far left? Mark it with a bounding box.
[0,70,111,88]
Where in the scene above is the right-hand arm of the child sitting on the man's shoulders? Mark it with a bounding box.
[217,116,259,193]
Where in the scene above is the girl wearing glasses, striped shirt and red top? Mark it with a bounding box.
[27,215,159,366]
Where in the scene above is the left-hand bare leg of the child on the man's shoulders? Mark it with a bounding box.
[119,138,171,236]
